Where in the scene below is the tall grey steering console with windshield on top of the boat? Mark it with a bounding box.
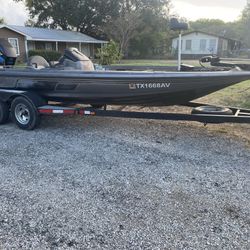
[59,48,94,71]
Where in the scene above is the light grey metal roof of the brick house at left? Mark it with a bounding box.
[0,25,107,43]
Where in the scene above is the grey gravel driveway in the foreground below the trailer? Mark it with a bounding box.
[0,114,250,250]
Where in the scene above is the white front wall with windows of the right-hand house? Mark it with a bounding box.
[172,32,219,55]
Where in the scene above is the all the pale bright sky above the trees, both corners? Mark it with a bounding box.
[0,0,247,25]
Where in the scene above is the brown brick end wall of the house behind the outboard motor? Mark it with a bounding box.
[0,28,26,62]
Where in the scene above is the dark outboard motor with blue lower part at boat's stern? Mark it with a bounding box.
[0,38,17,66]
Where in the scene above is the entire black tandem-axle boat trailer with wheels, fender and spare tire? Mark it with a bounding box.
[0,89,250,130]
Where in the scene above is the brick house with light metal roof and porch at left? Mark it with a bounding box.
[0,25,107,61]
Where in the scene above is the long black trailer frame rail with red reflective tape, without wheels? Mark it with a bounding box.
[38,102,250,124]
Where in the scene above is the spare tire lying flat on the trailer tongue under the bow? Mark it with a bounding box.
[192,106,233,115]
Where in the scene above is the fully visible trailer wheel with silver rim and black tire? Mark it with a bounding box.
[11,97,40,130]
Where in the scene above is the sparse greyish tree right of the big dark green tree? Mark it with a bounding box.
[105,0,170,57]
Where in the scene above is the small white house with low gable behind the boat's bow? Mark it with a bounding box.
[172,31,241,58]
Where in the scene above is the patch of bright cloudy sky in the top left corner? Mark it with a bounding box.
[0,0,28,25]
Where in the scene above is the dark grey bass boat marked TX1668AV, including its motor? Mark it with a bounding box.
[0,40,250,106]
